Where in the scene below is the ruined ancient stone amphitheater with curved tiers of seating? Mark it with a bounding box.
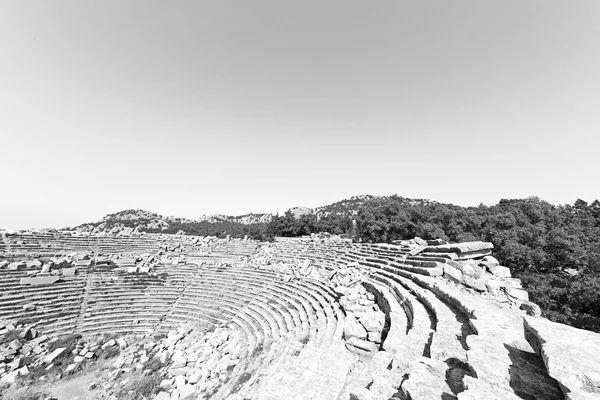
[0,232,600,400]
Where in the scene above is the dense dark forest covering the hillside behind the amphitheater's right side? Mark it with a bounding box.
[263,196,600,332]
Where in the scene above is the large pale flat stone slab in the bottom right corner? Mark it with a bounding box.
[523,317,600,399]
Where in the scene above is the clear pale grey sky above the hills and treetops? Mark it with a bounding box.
[0,0,600,229]
